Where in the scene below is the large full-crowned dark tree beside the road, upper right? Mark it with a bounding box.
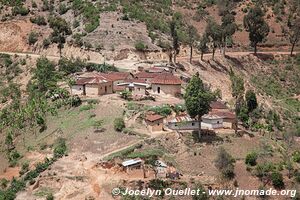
[244,5,270,55]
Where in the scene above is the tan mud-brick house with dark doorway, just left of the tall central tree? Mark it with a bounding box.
[151,73,182,96]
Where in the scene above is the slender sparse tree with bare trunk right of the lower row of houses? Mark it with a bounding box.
[230,69,245,134]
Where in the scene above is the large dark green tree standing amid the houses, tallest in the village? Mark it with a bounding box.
[184,73,215,140]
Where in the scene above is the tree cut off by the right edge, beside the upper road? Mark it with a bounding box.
[288,17,300,56]
